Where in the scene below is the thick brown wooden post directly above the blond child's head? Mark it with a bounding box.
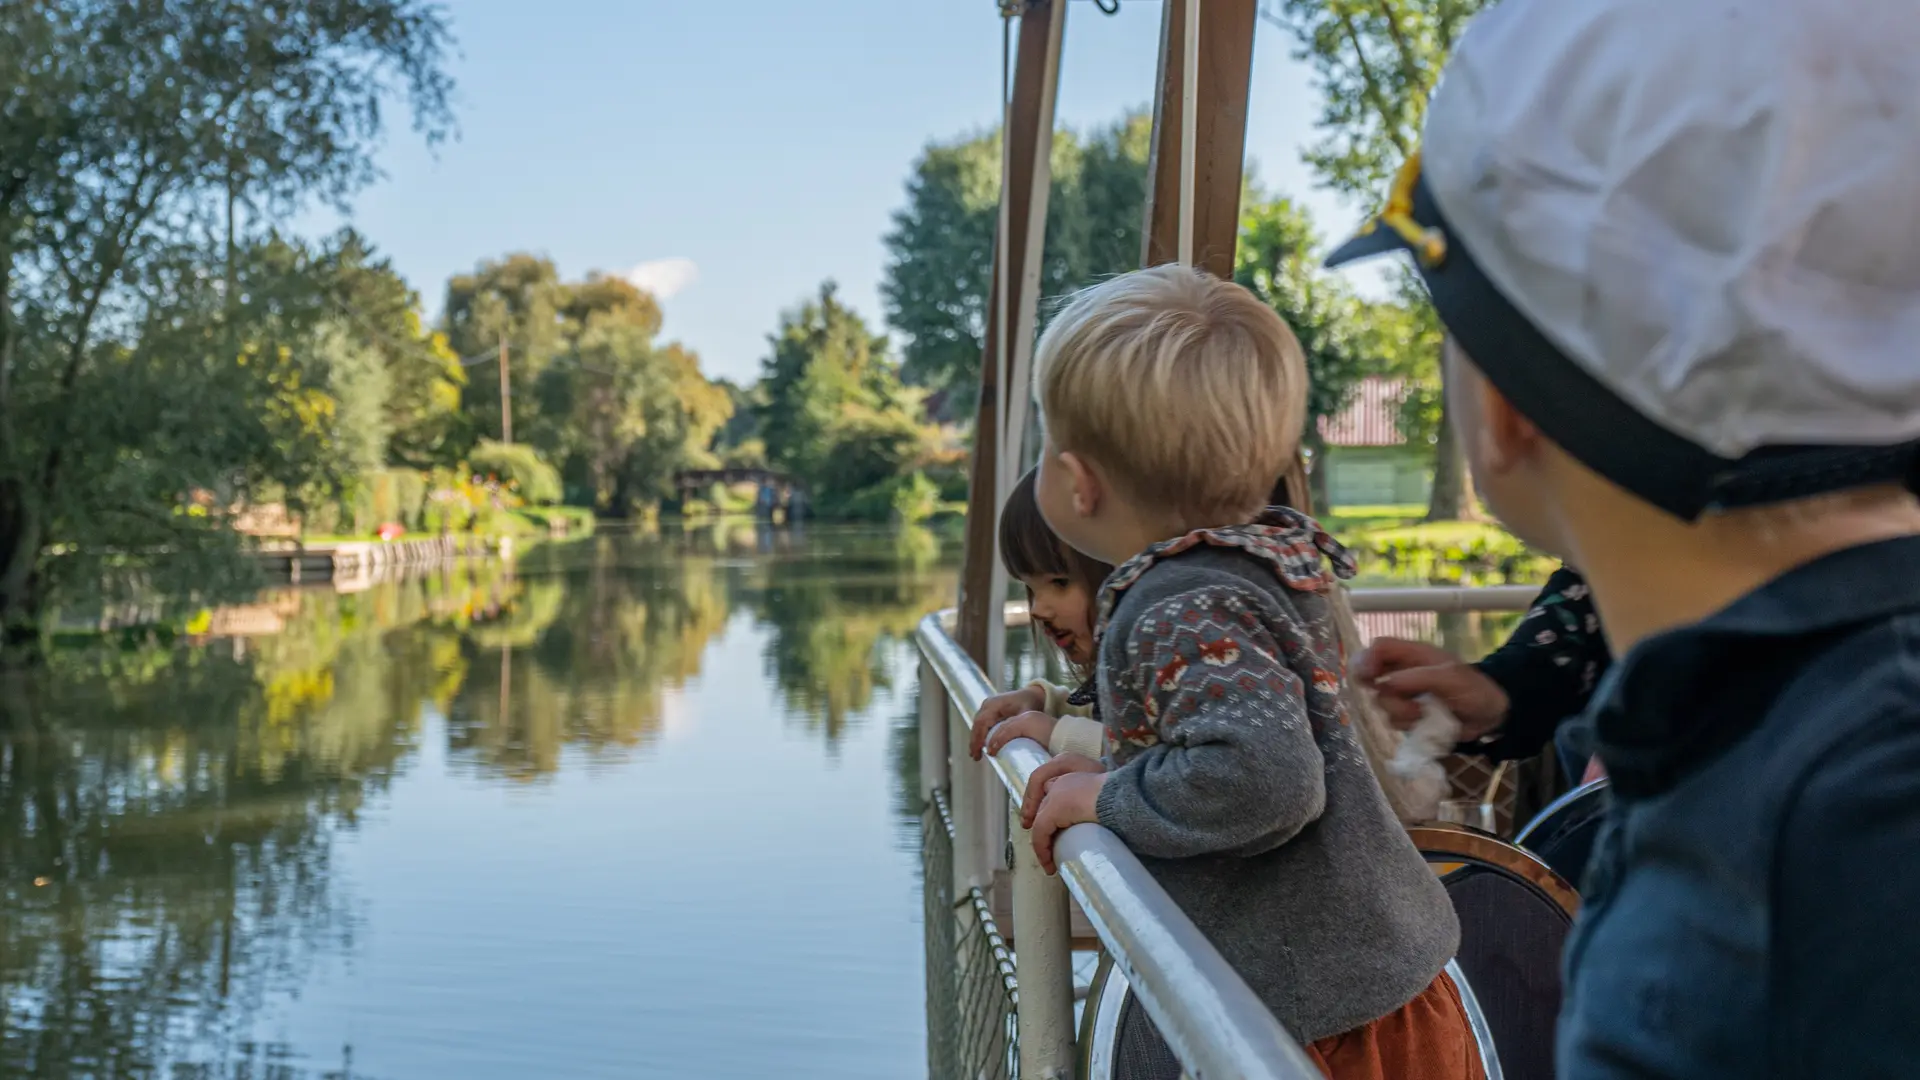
[1140,0,1260,279]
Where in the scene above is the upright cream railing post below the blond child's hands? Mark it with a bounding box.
[1014,814,1075,1080]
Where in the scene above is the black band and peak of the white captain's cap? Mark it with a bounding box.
[1327,177,1920,521]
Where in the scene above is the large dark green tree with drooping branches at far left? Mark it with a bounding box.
[0,0,449,634]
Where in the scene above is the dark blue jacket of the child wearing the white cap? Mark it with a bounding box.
[1559,538,1920,1080]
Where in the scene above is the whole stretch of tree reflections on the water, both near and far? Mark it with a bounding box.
[0,525,954,1080]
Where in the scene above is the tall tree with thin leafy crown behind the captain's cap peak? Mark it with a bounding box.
[1265,0,1490,521]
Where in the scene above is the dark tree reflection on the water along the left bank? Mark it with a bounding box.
[0,573,510,1078]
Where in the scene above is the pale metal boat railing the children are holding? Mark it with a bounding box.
[916,586,1536,1080]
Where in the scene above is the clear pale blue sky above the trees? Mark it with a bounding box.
[317,0,1356,380]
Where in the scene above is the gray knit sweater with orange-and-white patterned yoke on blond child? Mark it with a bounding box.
[1096,511,1459,1042]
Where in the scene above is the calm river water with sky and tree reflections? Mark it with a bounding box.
[0,527,958,1080]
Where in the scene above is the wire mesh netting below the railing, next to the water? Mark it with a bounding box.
[920,792,1020,1080]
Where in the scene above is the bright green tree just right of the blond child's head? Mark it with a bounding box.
[1235,198,1380,513]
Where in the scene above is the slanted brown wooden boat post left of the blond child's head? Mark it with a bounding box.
[954,0,1068,682]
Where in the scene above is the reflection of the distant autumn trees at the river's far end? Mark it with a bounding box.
[449,523,952,778]
